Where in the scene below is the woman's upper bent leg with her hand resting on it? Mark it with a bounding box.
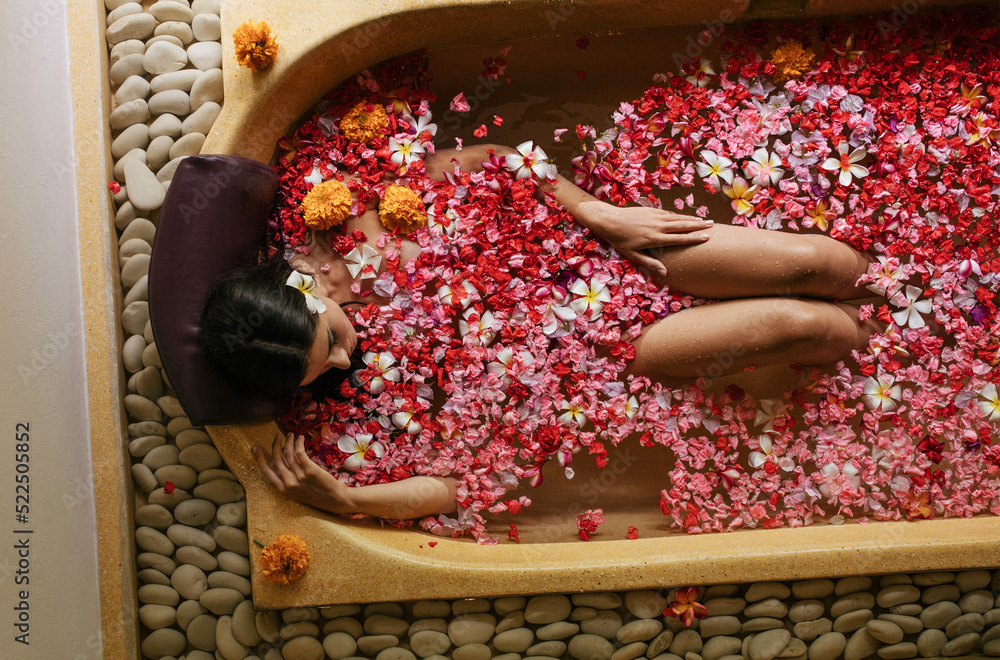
[649,225,872,300]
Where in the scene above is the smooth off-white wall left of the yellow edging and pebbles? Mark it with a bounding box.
[0,0,101,660]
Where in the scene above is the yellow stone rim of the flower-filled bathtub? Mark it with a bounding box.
[193,0,1000,608]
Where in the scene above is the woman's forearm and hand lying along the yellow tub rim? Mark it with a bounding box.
[253,434,458,520]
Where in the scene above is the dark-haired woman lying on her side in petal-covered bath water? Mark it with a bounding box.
[202,145,879,519]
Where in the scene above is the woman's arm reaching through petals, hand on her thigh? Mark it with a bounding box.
[424,144,714,275]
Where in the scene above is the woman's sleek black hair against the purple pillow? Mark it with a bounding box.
[198,255,316,396]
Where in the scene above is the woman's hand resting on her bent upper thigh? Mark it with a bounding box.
[580,202,714,275]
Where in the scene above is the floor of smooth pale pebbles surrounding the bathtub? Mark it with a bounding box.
[104,0,1000,660]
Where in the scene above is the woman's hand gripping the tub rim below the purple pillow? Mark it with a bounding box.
[253,433,357,514]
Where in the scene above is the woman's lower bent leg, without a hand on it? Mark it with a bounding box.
[629,298,879,380]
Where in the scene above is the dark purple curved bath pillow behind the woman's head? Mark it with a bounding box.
[149,155,284,426]
